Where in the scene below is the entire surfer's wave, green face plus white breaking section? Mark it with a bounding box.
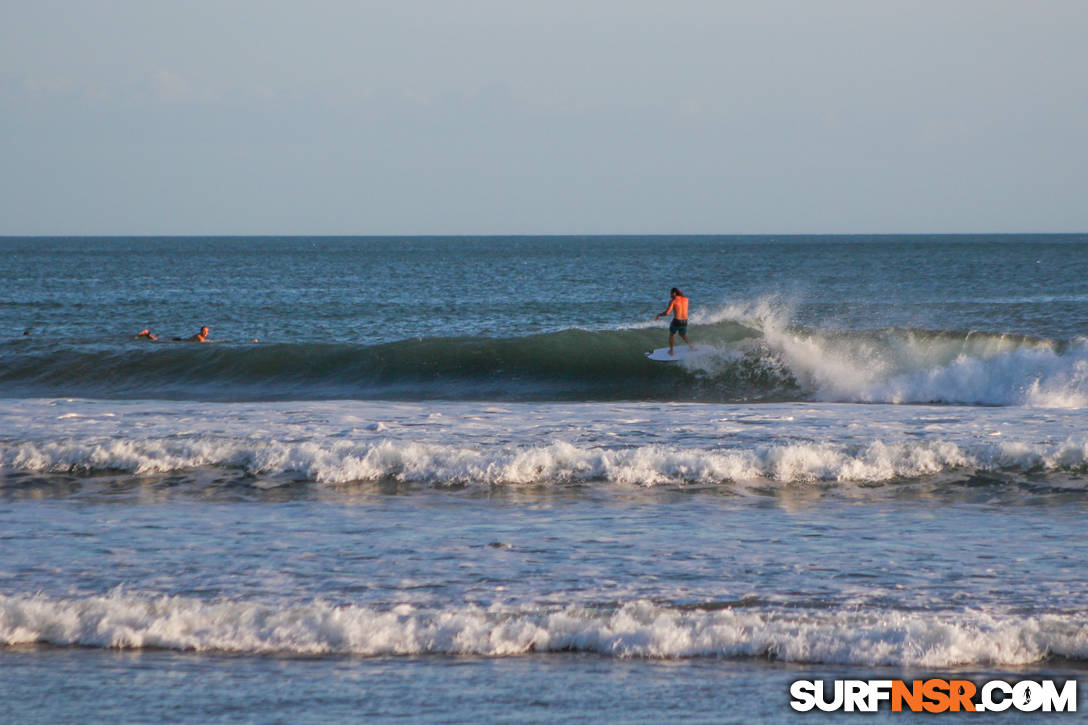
[0,320,1088,407]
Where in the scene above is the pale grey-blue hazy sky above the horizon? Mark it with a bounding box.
[0,0,1088,235]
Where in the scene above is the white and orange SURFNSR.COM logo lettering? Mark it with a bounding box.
[790,678,1077,713]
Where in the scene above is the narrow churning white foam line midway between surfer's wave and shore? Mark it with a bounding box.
[0,438,1088,486]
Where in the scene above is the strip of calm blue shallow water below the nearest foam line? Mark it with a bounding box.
[0,647,1086,723]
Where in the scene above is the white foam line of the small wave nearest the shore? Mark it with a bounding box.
[0,592,1088,667]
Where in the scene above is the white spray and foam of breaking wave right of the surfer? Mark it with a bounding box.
[688,298,1088,409]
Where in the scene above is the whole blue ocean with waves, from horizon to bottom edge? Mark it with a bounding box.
[0,234,1088,723]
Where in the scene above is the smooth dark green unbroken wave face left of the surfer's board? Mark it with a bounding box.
[0,323,774,401]
